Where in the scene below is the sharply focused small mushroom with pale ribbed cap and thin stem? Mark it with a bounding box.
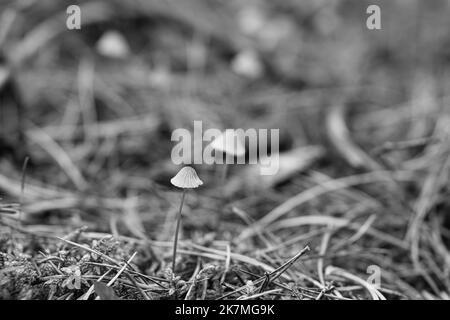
[170,166,203,273]
